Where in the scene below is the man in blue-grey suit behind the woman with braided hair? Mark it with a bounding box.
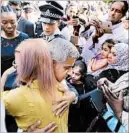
[8,0,34,38]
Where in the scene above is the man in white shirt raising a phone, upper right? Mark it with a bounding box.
[82,1,128,62]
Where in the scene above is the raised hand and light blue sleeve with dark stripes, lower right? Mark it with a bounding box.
[101,84,128,133]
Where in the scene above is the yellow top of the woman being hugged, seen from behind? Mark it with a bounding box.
[2,81,68,133]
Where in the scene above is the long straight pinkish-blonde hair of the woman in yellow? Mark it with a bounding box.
[15,39,56,94]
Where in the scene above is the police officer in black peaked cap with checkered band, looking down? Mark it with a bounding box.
[39,2,65,42]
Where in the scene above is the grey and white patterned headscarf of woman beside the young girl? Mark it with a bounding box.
[108,43,129,71]
